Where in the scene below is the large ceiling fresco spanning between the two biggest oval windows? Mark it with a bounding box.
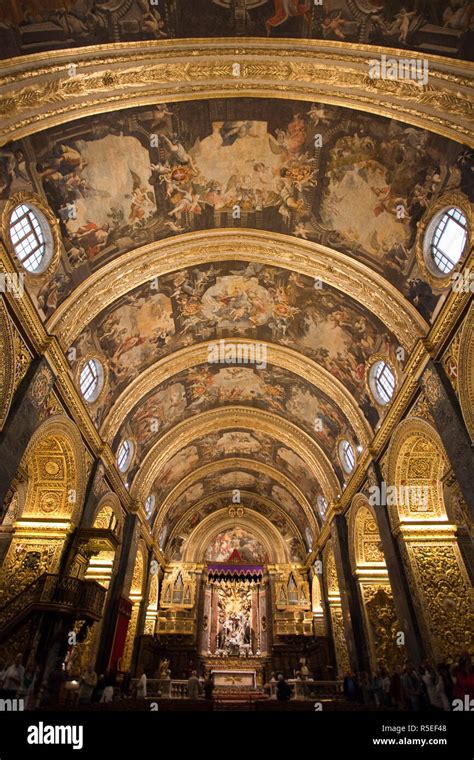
[0,98,474,320]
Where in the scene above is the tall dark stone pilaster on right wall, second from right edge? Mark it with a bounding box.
[372,462,426,662]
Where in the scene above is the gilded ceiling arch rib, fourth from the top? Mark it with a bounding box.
[130,406,338,498]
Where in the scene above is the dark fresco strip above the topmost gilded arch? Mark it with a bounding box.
[0,0,474,59]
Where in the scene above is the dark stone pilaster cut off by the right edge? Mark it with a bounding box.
[421,360,474,519]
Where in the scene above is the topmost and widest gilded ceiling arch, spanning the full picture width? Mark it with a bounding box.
[0,38,474,145]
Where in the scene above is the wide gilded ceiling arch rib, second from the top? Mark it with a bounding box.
[46,229,428,350]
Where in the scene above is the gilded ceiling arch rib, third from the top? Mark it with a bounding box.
[100,338,371,445]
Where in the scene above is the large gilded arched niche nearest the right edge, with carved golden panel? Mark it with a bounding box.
[388,417,473,662]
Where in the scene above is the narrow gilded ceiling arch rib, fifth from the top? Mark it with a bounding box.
[153,457,318,538]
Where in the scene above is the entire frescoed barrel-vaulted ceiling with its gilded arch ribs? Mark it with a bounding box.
[0,0,474,560]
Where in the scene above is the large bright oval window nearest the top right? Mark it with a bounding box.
[427,208,467,276]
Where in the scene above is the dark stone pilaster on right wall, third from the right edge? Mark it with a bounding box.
[333,514,370,672]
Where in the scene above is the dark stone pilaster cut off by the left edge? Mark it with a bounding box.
[0,358,55,506]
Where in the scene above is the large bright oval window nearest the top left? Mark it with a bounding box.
[10,203,52,274]
